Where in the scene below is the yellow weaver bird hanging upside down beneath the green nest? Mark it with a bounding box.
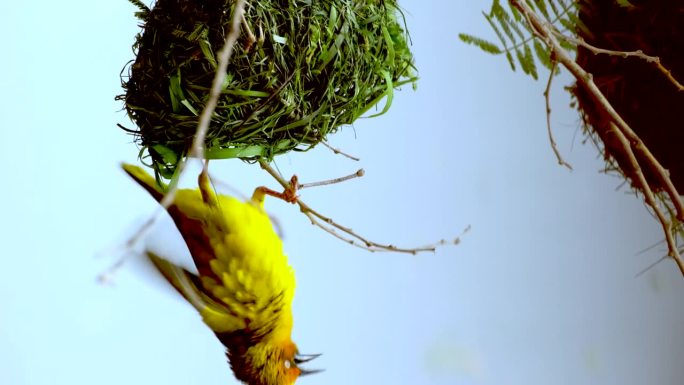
[122,164,318,385]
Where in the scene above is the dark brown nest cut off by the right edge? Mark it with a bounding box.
[574,0,684,193]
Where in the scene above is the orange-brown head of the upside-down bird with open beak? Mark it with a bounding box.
[228,341,321,385]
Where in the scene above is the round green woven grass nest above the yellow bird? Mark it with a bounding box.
[118,0,416,178]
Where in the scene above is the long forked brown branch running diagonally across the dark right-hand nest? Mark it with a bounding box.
[511,0,684,275]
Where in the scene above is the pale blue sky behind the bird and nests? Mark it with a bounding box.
[0,0,684,385]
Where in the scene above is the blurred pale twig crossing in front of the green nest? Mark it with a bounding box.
[103,0,245,282]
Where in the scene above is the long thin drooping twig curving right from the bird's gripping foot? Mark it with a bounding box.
[259,161,462,255]
